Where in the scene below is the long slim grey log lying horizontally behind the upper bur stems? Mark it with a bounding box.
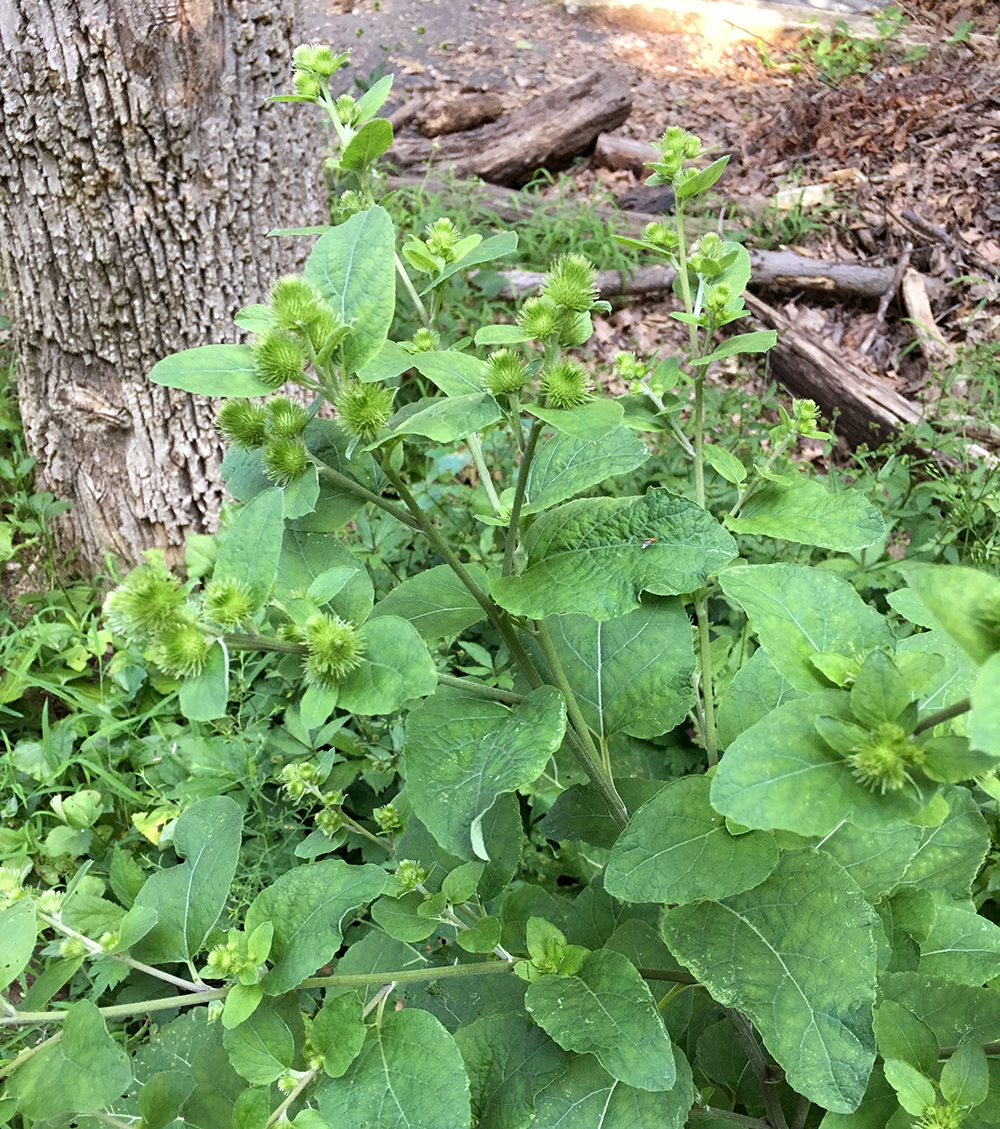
[489,251,893,298]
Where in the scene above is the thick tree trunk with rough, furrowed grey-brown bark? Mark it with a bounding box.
[0,0,325,568]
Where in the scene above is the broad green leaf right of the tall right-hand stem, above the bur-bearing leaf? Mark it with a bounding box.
[719,565,893,692]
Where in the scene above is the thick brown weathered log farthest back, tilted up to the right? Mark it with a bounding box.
[388,70,632,187]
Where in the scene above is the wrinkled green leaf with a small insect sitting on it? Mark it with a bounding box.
[490,487,736,620]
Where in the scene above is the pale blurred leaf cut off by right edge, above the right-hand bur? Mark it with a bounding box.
[902,565,1000,666]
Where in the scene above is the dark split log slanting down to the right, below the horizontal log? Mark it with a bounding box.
[745,294,921,447]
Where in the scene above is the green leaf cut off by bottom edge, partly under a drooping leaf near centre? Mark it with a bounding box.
[534,1049,704,1129]
